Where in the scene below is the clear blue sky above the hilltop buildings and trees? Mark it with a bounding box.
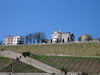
[0,0,100,40]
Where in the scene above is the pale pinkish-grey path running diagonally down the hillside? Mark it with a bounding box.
[0,50,61,73]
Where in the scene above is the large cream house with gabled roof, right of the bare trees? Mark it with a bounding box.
[52,31,74,43]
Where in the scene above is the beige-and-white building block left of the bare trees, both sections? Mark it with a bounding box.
[4,36,22,45]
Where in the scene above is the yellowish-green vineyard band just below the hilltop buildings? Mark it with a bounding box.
[0,43,100,56]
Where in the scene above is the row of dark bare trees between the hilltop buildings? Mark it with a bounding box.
[21,32,46,44]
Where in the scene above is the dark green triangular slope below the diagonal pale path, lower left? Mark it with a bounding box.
[0,57,44,73]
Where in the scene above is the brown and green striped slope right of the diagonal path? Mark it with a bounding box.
[33,55,100,75]
